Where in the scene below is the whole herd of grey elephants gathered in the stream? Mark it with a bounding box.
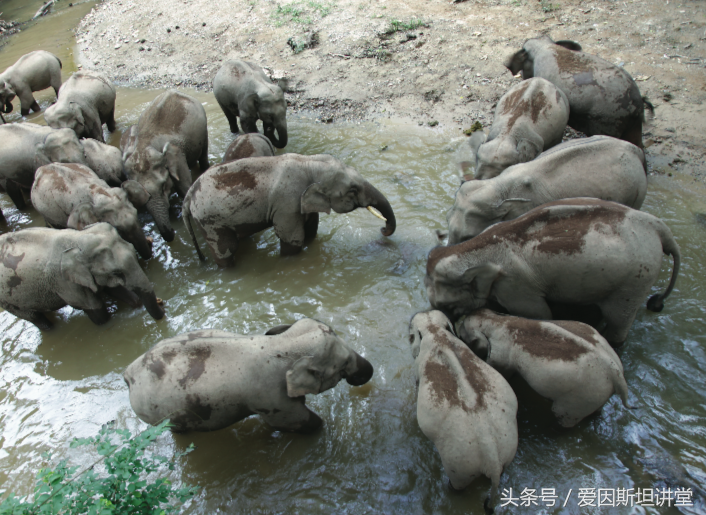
[0,36,680,509]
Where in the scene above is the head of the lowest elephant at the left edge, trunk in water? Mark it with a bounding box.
[60,223,164,320]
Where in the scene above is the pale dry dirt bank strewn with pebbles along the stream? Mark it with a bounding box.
[76,0,706,180]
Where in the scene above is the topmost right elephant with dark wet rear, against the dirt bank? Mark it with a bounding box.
[505,36,654,148]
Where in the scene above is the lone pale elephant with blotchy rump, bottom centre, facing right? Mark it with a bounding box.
[124,318,373,433]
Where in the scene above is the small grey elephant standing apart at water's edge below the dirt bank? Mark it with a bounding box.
[213,59,287,148]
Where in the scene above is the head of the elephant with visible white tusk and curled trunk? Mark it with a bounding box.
[301,155,397,236]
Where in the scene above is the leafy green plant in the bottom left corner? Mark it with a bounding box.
[0,420,198,515]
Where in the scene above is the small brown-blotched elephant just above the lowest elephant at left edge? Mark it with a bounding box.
[31,163,152,259]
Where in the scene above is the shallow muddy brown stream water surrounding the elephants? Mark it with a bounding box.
[0,5,706,514]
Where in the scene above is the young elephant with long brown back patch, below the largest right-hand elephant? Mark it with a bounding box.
[459,309,628,427]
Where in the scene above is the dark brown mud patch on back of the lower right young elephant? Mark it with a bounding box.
[507,317,588,362]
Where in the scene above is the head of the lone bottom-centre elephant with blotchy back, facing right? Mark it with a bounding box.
[282,319,373,397]
